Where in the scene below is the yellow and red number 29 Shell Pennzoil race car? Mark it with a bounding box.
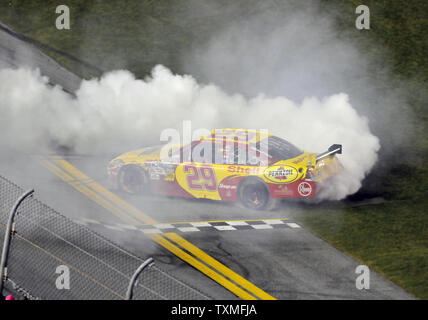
[107,129,342,210]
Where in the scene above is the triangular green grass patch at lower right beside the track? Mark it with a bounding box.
[296,199,428,299]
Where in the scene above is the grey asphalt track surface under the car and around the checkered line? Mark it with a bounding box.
[0,23,414,299]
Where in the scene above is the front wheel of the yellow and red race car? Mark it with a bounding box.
[118,165,149,194]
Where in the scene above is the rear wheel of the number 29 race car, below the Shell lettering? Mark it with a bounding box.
[238,179,270,210]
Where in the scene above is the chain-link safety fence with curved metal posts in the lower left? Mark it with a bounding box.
[0,176,210,300]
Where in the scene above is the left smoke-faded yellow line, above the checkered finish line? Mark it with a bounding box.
[41,159,141,225]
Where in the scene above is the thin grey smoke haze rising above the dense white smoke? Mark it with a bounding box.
[181,0,414,162]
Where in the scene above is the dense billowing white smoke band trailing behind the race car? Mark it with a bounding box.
[0,66,379,199]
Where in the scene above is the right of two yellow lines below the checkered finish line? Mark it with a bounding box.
[165,233,276,300]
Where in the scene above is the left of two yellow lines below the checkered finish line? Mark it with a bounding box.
[151,234,257,300]
